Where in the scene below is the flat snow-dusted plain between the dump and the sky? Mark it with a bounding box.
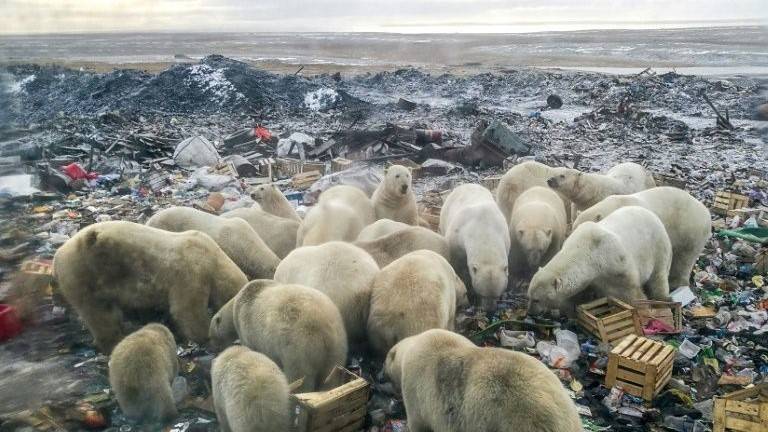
[0,26,768,75]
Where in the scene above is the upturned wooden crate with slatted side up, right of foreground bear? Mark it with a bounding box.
[605,335,675,401]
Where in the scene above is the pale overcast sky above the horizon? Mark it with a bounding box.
[0,0,768,33]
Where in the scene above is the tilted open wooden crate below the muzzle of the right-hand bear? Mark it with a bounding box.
[576,297,643,345]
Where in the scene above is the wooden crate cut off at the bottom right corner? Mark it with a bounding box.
[712,383,768,432]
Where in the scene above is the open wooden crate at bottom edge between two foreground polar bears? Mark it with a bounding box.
[291,366,370,432]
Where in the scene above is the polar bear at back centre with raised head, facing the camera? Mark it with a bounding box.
[371,165,419,225]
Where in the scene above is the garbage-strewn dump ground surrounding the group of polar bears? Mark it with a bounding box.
[0,56,768,432]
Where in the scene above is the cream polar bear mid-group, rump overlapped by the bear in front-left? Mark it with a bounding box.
[275,241,379,343]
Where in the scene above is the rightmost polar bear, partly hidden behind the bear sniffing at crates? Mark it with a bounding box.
[573,187,712,288]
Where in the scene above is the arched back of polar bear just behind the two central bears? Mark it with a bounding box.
[354,225,451,267]
